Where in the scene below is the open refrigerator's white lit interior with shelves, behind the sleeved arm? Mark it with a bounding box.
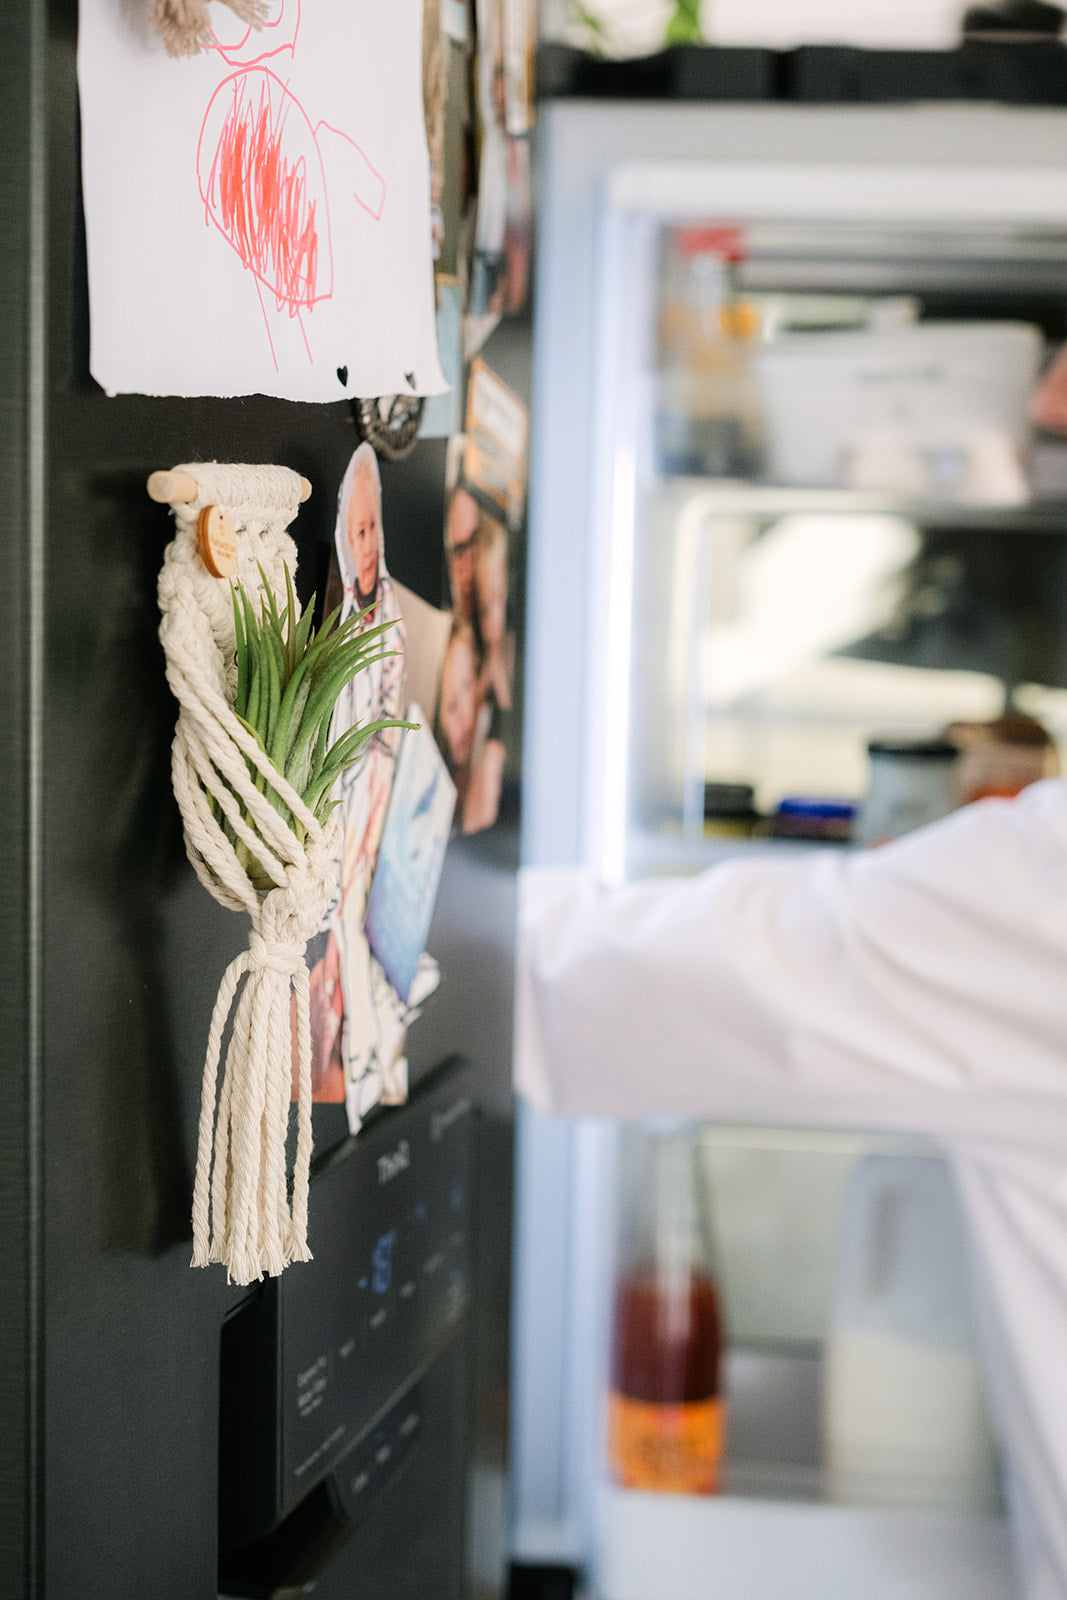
[512,84,1067,1600]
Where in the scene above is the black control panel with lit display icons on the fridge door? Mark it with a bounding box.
[219,1066,474,1549]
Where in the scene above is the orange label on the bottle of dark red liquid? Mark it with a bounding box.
[608,1392,726,1494]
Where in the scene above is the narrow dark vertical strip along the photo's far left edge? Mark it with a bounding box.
[0,0,43,1594]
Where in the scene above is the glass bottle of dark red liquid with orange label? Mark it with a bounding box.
[608,1126,725,1494]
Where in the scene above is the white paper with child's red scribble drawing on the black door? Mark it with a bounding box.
[78,0,448,400]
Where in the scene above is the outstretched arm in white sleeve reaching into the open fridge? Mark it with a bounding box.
[517,781,1067,1150]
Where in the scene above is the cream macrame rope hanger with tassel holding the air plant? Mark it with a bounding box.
[158,461,339,1283]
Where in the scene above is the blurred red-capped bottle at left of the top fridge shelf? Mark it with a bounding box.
[656,227,765,478]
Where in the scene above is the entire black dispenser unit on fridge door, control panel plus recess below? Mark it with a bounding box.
[219,1061,482,1600]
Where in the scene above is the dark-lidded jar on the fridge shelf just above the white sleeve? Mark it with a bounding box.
[854,739,960,845]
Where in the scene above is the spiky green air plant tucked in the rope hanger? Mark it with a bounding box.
[214,566,418,890]
